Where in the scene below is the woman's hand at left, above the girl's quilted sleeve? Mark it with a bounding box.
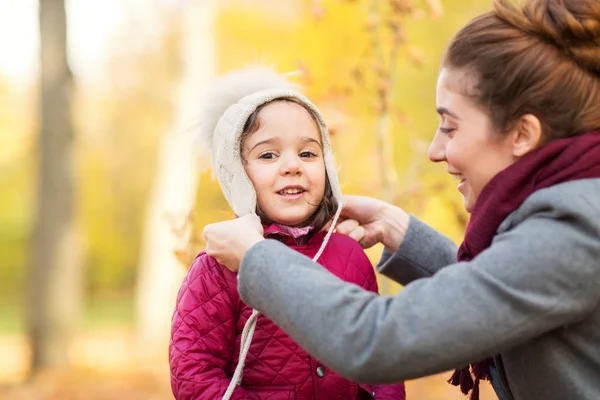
[204,214,264,272]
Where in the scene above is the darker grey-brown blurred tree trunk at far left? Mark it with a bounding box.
[28,0,82,372]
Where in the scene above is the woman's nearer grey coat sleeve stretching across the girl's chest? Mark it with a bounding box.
[238,203,600,383]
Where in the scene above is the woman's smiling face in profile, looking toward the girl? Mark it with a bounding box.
[428,68,517,212]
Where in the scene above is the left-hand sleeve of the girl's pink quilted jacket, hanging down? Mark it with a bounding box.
[169,253,252,400]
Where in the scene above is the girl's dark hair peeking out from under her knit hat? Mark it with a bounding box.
[240,98,338,233]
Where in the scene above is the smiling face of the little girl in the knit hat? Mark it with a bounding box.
[242,101,326,226]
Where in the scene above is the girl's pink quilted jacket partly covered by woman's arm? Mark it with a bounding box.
[169,229,405,400]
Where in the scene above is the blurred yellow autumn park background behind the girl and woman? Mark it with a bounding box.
[0,0,493,400]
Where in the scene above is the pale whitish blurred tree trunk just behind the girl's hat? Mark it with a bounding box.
[136,0,215,358]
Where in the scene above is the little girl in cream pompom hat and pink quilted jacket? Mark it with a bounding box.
[169,68,405,400]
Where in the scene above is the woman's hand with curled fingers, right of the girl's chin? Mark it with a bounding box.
[336,195,409,252]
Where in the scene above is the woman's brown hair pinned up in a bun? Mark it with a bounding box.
[442,0,600,142]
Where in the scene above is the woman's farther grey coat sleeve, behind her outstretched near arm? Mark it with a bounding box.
[377,215,458,285]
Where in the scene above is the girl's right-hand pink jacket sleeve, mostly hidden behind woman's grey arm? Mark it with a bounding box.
[349,242,406,400]
